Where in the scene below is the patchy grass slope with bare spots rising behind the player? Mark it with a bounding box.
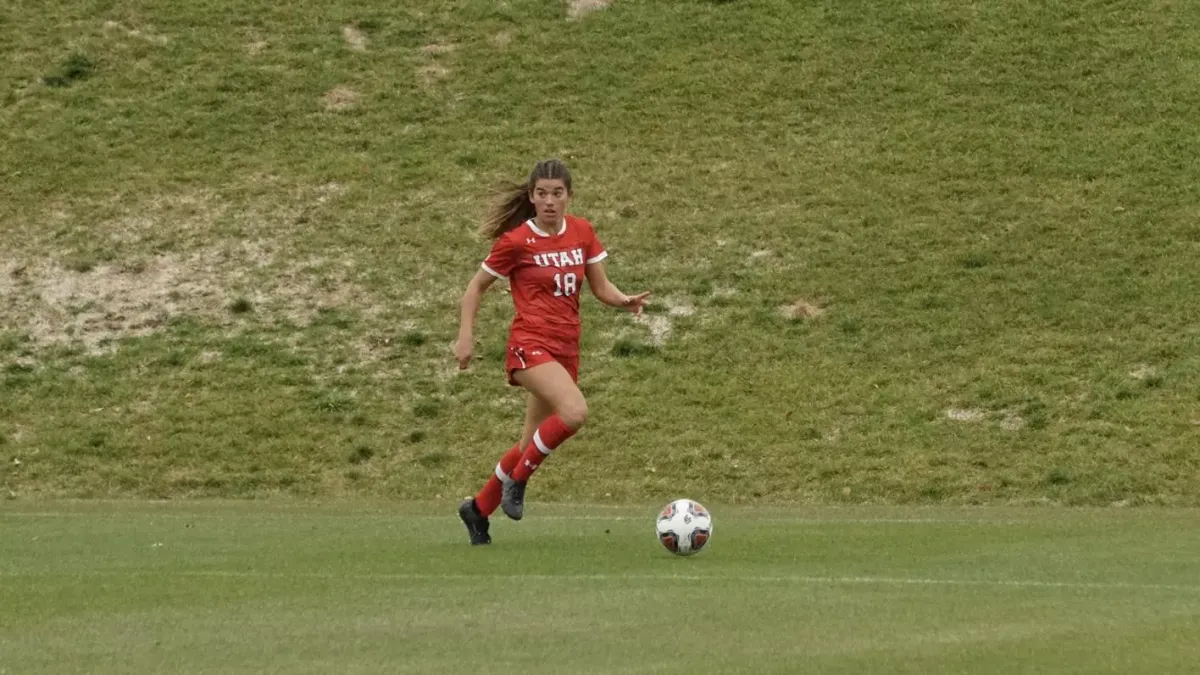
[0,0,1200,506]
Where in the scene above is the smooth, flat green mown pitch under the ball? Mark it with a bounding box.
[0,502,1200,675]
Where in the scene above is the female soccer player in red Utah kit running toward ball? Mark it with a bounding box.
[454,160,649,544]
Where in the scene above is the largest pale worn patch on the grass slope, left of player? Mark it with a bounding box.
[0,189,380,353]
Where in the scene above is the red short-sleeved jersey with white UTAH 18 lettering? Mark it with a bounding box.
[482,215,608,356]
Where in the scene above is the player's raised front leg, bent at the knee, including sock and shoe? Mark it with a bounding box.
[500,362,588,520]
